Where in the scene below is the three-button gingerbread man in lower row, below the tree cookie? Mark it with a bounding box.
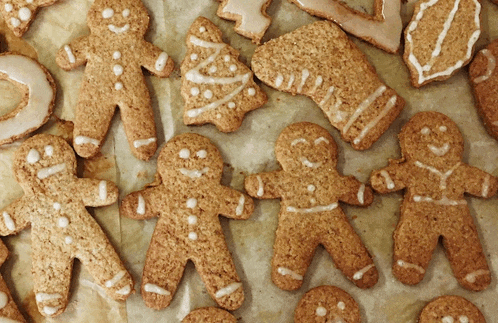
[121,133,254,310]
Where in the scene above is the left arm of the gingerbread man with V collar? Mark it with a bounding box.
[370,164,406,193]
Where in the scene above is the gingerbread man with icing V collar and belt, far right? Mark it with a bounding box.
[370,112,498,291]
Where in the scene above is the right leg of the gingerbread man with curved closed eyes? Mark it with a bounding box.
[319,213,379,288]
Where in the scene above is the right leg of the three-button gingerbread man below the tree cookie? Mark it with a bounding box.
[193,236,244,311]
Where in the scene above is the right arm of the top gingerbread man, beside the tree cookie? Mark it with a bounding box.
[141,40,175,77]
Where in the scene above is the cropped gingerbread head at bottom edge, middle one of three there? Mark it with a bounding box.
[294,286,361,323]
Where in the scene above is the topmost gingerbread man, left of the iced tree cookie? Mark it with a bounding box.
[57,0,174,160]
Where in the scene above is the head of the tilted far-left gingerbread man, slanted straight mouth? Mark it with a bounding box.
[13,134,76,192]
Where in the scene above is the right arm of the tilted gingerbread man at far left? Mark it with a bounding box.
[74,178,119,207]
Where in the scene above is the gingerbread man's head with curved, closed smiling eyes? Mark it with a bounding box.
[275,122,337,172]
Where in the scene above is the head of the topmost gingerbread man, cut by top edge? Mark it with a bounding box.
[87,0,149,38]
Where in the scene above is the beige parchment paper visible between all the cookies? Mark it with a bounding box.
[0,0,498,323]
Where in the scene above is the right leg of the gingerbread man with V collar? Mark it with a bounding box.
[442,206,491,291]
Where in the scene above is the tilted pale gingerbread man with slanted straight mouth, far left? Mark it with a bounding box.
[0,134,133,317]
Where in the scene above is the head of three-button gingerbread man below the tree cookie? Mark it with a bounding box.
[157,133,223,187]
